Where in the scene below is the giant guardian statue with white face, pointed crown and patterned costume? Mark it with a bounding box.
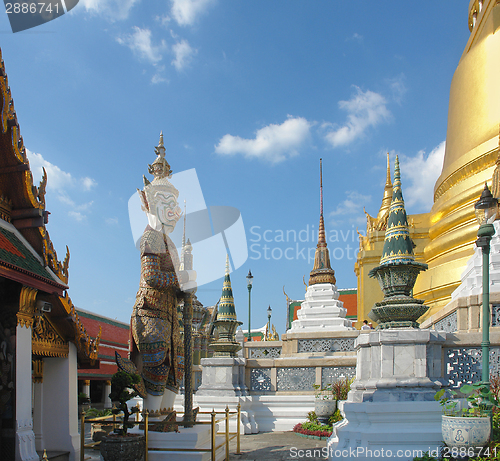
[116,134,184,400]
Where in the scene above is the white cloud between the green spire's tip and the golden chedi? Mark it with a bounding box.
[399,141,446,213]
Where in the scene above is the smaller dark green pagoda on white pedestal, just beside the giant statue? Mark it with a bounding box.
[208,256,243,357]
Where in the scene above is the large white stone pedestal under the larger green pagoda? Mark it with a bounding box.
[327,329,446,461]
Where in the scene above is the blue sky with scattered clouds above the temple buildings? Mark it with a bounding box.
[0,0,469,334]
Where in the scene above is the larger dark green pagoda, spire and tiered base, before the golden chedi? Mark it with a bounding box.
[368,156,429,329]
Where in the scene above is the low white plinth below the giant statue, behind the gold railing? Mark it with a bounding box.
[129,424,225,461]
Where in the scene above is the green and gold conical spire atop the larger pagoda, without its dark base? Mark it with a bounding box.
[380,156,422,266]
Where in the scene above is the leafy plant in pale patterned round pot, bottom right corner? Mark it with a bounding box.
[434,383,498,453]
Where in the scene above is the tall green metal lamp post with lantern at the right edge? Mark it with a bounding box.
[474,184,498,392]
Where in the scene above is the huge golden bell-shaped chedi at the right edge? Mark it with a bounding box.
[414,0,500,317]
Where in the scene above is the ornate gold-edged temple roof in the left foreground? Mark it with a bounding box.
[0,46,99,366]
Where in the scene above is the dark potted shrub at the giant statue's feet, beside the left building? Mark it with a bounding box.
[100,371,146,461]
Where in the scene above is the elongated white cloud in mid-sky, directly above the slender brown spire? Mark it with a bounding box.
[215,115,312,163]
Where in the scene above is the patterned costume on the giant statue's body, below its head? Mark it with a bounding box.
[131,226,183,395]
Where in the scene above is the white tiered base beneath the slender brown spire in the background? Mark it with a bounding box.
[291,283,354,332]
